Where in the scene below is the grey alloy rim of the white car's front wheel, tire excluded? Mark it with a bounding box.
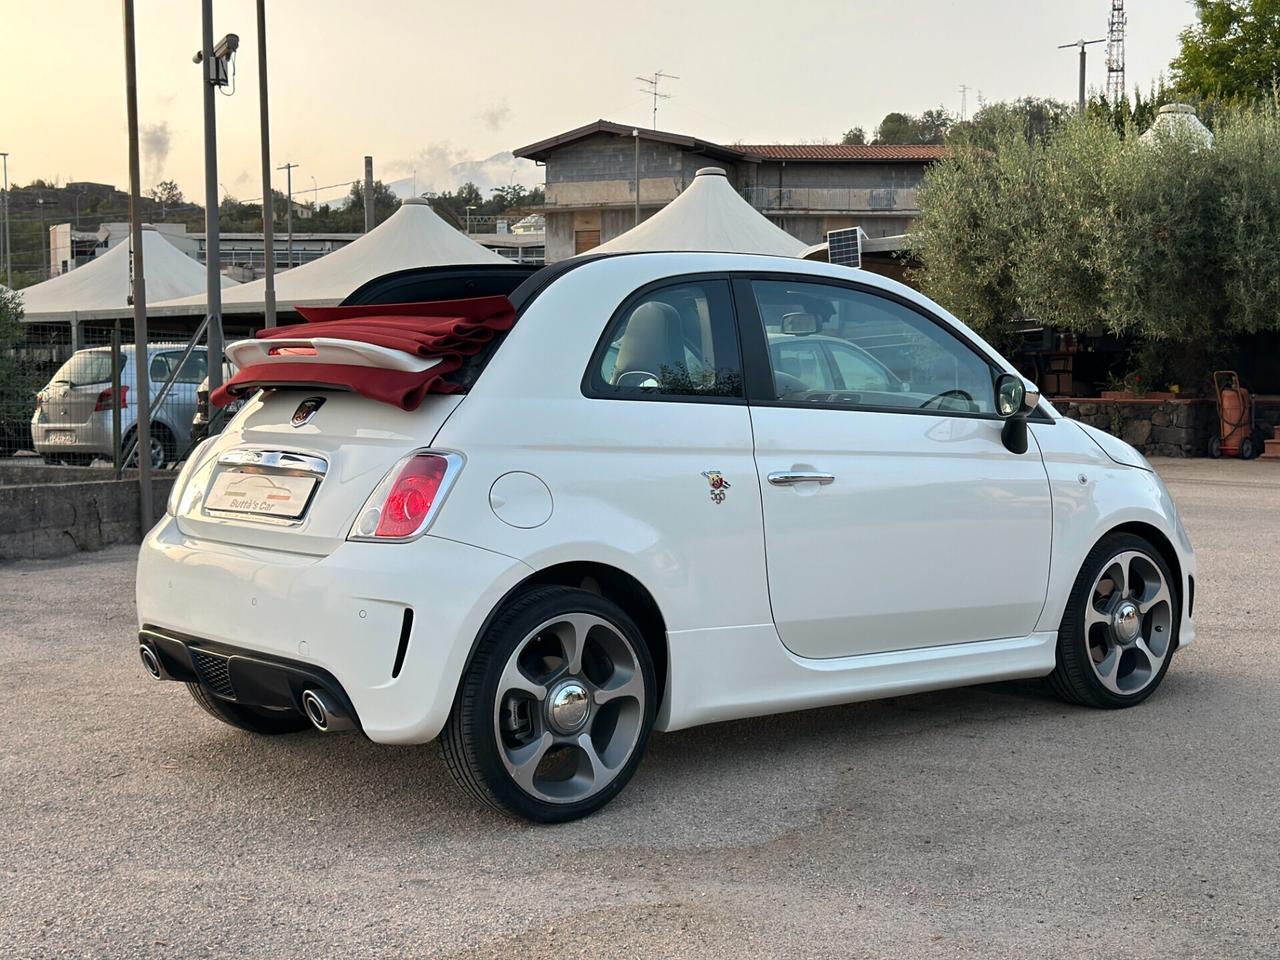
[1084,550,1174,696]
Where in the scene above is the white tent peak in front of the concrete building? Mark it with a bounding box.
[591,166,805,257]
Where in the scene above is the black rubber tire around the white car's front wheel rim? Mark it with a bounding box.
[1048,534,1181,709]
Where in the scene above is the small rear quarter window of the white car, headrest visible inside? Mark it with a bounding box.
[588,280,742,398]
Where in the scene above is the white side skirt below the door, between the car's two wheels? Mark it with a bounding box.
[657,623,1057,731]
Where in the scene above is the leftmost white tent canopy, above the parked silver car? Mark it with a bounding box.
[19,228,236,323]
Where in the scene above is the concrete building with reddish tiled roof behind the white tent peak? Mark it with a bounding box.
[513,120,946,262]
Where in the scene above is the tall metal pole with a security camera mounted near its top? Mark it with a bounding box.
[194,0,239,394]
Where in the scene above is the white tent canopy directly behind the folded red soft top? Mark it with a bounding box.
[147,197,511,316]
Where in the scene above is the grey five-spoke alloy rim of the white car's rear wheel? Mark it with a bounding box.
[493,613,645,804]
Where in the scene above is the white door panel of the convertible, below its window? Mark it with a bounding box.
[751,407,1051,658]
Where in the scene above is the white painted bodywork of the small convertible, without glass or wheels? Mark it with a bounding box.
[137,253,1194,742]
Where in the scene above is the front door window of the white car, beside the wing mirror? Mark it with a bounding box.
[751,280,996,413]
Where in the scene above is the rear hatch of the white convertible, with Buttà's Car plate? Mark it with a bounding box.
[178,389,462,556]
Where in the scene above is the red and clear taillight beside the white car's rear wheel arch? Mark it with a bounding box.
[349,453,462,540]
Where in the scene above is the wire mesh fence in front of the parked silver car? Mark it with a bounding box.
[0,320,220,471]
